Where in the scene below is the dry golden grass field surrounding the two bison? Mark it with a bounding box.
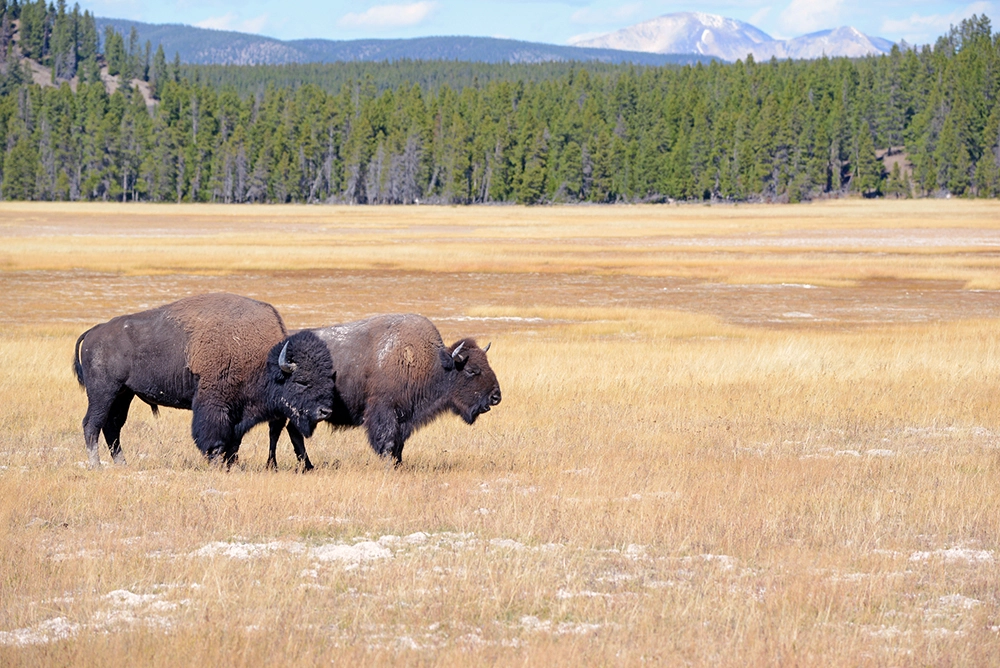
[0,201,1000,666]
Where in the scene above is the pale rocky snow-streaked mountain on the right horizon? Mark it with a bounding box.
[576,12,892,60]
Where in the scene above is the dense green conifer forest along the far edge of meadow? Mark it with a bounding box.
[0,10,1000,204]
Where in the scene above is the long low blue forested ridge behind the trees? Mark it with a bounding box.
[96,18,713,65]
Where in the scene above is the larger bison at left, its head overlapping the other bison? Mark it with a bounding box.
[73,294,334,468]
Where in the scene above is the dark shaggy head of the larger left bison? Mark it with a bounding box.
[267,331,336,437]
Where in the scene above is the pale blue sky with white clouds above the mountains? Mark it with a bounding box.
[80,0,1000,44]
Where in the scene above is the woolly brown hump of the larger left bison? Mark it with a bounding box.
[167,293,286,382]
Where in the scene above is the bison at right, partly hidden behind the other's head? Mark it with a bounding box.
[268,314,500,467]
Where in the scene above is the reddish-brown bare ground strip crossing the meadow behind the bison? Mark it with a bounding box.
[0,270,1000,335]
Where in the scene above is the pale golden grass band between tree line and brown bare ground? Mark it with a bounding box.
[0,201,1000,287]
